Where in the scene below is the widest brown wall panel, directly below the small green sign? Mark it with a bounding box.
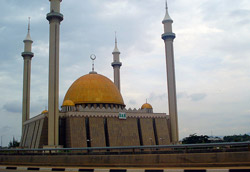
[107,118,140,146]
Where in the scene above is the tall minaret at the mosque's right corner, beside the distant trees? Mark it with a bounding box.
[162,1,179,144]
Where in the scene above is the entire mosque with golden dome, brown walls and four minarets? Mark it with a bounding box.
[20,0,178,148]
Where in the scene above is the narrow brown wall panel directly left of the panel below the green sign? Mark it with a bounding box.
[89,117,106,147]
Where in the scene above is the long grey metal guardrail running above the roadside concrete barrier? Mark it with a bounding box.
[0,141,250,155]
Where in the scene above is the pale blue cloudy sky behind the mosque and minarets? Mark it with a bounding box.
[0,0,250,146]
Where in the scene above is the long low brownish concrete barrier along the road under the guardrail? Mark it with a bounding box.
[0,151,250,168]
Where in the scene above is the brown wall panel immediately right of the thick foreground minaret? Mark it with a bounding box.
[66,117,87,148]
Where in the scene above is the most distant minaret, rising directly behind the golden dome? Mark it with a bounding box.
[111,34,122,92]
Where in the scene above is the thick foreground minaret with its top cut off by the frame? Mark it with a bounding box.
[47,0,63,147]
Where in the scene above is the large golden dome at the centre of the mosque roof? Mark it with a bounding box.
[64,73,124,105]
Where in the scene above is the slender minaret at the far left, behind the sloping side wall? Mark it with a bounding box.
[22,18,34,132]
